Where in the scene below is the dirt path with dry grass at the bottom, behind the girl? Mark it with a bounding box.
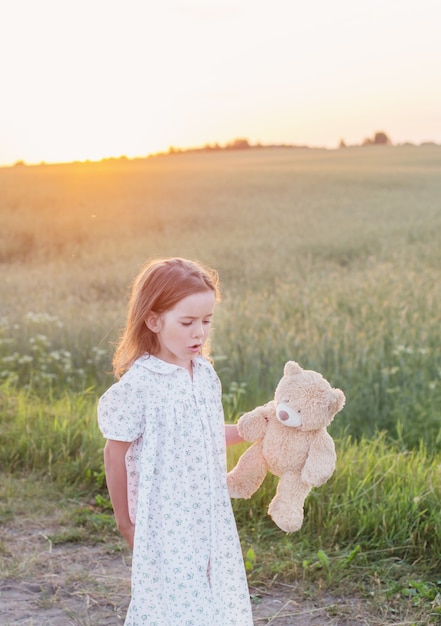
[0,537,373,626]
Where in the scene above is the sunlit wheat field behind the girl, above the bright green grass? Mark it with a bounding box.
[0,146,441,447]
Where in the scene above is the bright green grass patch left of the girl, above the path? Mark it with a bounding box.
[0,385,104,488]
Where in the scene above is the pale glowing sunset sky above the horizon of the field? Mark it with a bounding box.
[0,0,441,165]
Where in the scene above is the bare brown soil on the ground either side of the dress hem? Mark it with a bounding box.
[0,523,426,626]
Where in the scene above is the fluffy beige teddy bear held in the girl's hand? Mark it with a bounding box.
[227,361,346,533]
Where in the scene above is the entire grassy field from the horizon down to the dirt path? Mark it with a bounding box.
[0,146,441,610]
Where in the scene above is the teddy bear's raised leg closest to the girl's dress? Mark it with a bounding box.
[227,442,268,498]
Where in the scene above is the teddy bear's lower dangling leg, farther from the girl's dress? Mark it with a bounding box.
[268,472,311,533]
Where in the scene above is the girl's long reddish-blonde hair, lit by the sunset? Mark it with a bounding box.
[113,257,220,378]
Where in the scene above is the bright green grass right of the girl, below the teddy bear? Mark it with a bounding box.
[230,435,441,574]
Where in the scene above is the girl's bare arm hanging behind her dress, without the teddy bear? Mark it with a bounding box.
[104,439,135,548]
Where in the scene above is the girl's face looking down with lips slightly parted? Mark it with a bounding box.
[146,290,216,371]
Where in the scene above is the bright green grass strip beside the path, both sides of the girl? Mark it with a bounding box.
[0,378,441,583]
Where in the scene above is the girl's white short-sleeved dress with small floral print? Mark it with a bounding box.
[98,355,253,626]
